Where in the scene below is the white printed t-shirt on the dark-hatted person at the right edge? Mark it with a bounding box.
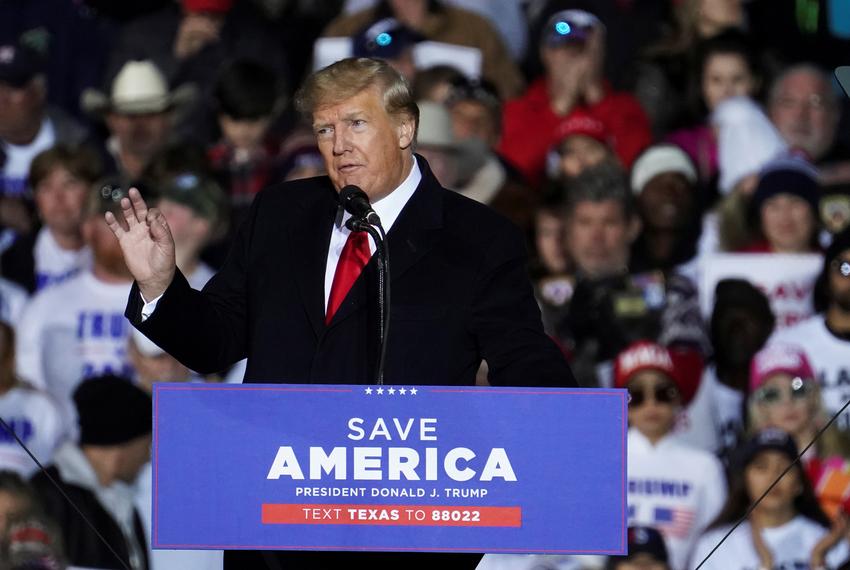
[768,315,850,431]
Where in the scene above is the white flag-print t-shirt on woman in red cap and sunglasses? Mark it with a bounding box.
[627,428,726,570]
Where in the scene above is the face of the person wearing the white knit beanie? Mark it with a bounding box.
[638,172,693,230]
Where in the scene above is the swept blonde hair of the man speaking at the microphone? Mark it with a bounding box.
[295,57,419,136]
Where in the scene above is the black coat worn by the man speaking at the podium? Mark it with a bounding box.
[127,157,575,568]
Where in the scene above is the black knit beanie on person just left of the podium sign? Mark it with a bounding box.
[74,374,153,445]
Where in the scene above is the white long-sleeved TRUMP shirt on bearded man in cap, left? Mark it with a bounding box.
[17,271,132,418]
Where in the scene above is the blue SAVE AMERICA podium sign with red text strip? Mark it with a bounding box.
[152,384,627,554]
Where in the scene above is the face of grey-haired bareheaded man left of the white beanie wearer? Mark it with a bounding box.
[567,200,636,277]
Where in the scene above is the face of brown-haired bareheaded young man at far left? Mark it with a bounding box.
[34,166,88,234]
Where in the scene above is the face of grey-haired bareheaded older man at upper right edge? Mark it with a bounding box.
[768,71,838,160]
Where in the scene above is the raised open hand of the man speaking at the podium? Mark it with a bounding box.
[106,188,177,301]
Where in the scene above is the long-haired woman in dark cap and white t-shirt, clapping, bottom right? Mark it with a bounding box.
[690,429,850,570]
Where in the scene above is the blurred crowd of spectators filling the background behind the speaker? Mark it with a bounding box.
[0,0,850,570]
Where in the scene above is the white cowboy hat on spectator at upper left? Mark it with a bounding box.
[80,60,197,115]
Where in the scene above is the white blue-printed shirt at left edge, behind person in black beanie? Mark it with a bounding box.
[0,385,67,478]
